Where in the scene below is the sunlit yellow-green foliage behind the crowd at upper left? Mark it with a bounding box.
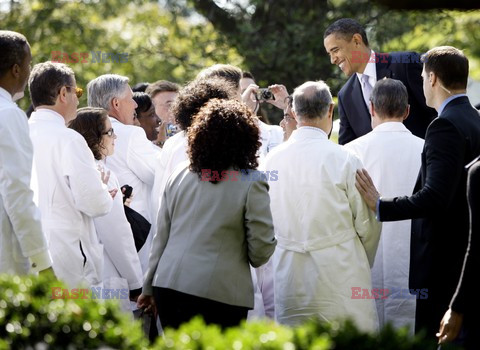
[0,0,243,109]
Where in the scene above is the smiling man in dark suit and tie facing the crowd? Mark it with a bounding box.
[324,18,436,145]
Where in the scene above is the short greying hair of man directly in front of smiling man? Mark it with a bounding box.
[370,78,408,118]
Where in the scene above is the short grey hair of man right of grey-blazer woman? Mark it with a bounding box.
[293,80,333,119]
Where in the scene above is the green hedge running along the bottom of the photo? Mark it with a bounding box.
[0,275,460,350]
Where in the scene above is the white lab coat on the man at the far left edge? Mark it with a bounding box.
[0,88,52,275]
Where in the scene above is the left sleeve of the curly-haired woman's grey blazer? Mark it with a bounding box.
[143,189,171,295]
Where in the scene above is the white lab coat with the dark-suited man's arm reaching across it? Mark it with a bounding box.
[345,122,424,334]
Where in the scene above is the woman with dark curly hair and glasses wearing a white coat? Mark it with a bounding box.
[68,107,143,311]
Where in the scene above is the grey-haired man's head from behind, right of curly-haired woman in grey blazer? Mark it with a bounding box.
[292,80,335,136]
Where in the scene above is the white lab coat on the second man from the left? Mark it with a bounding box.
[29,109,112,287]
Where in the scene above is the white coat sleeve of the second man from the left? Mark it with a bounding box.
[63,135,113,217]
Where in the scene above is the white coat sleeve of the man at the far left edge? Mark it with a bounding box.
[0,108,52,271]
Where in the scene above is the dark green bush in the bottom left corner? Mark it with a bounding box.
[0,275,148,349]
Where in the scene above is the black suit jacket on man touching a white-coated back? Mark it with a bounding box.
[378,97,480,318]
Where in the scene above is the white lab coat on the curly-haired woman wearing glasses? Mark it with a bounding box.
[93,160,143,311]
